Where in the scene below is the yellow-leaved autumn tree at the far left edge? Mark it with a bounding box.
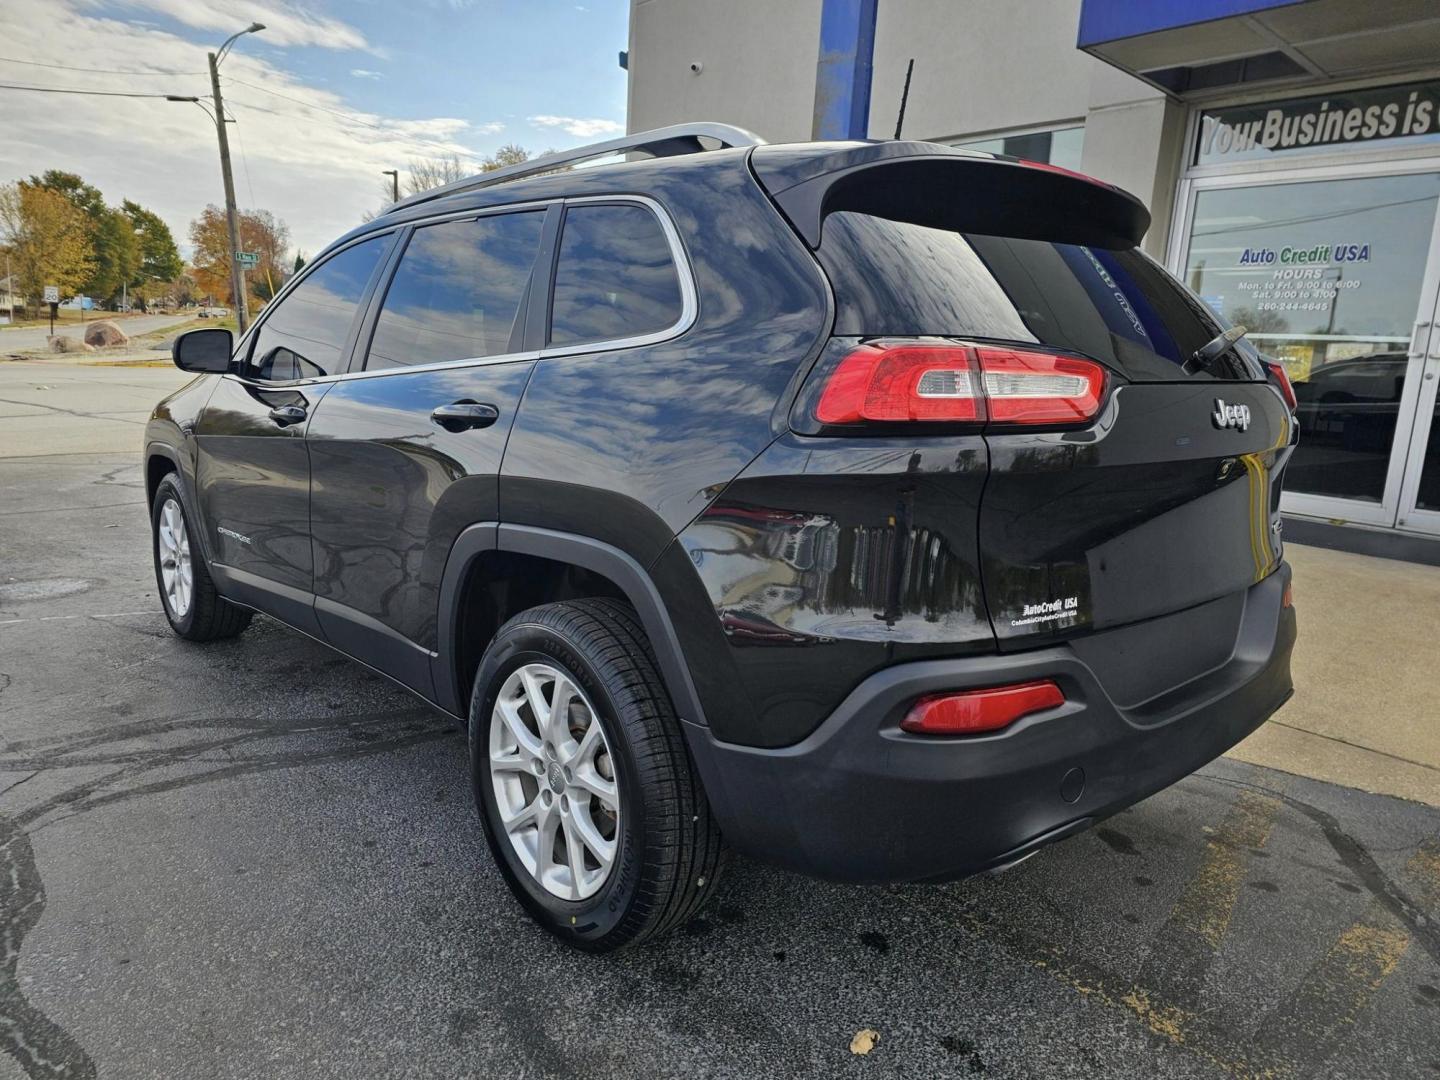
[0,181,95,304]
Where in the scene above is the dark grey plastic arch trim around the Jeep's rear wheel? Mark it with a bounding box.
[433,521,706,726]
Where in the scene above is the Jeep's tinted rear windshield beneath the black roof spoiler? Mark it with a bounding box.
[818,210,1254,382]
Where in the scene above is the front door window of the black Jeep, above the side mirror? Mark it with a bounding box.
[249,233,390,382]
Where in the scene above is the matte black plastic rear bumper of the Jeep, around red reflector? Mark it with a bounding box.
[687,566,1296,881]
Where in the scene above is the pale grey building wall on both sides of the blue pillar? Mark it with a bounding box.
[628,0,1185,255]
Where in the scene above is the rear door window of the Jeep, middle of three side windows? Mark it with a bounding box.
[366,212,544,370]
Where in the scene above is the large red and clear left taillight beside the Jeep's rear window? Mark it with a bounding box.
[815,343,1106,425]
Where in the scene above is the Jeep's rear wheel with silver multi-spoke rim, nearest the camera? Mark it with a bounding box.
[469,599,724,952]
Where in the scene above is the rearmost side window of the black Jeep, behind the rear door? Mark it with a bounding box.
[550,203,684,346]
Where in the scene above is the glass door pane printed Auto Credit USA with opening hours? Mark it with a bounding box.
[1185,173,1440,503]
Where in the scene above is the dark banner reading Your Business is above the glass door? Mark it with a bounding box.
[1194,81,1440,166]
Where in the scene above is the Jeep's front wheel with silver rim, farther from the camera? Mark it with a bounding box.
[150,474,251,641]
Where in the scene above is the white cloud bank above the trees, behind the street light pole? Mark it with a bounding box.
[0,0,504,252]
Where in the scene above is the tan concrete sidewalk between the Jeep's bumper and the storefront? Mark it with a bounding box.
[1230,544,1440,806]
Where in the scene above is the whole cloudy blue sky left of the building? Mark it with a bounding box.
[0,0,629,255]
